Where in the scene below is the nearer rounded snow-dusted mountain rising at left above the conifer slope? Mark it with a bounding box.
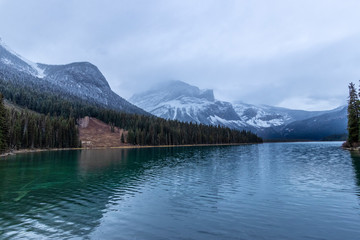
[0,40,148,114]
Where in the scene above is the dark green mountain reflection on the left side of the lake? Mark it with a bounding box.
[0,148,215,239]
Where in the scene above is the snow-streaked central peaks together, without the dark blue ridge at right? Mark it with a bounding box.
[130,81,293,129]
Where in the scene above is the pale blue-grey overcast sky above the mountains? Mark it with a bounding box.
[0,0,360,110]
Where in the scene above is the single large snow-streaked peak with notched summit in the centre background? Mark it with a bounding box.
[129,81,241,127]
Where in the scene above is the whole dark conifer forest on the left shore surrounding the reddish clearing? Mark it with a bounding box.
[0,78,262,154]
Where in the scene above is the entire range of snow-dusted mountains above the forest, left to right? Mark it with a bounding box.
[0,39,347,140]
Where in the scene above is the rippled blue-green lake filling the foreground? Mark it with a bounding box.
[0,142,360,240]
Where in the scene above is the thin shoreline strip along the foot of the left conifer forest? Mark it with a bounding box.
[0,143,261,159]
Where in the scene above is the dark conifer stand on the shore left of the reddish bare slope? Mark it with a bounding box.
[0,94,79,152]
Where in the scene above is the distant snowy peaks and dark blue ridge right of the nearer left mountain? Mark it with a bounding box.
[129,81,347,140]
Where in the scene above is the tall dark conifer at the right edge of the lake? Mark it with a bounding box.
[348,83,359,144]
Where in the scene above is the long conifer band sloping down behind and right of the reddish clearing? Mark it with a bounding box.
[0,76,262,150]
